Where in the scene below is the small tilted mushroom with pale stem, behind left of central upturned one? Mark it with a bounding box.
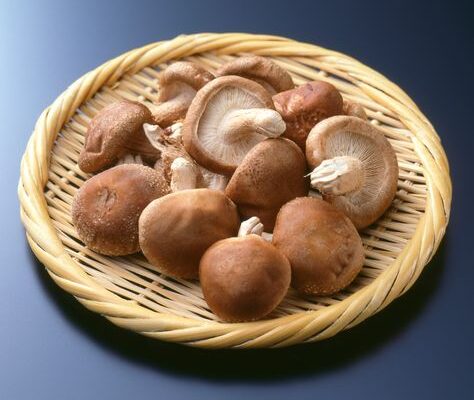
[153,61,214,127]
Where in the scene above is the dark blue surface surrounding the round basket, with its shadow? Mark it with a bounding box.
[0,0,474,400]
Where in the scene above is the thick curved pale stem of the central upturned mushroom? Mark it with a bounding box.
[218,108,286,144]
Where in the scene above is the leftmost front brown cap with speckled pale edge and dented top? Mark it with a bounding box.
[72,164,169,256]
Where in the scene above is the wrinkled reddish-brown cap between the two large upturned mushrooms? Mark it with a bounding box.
[273,81,343,151]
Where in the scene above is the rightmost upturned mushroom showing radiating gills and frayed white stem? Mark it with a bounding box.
[306,116,398,229]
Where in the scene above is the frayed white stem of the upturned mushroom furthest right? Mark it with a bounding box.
[310,156,365,196]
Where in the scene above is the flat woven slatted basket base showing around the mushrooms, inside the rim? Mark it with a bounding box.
[45,53,427,320]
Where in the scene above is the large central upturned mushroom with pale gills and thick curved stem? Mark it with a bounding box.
[183,76,285,175]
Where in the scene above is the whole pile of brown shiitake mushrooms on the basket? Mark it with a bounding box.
[72,56,398,322]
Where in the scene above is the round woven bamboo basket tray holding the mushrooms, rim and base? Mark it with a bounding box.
[18,33,451,348]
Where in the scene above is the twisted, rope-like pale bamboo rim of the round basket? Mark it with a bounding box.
[18,33,452,347]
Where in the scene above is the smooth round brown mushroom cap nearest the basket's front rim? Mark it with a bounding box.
[199,235,291,322]
